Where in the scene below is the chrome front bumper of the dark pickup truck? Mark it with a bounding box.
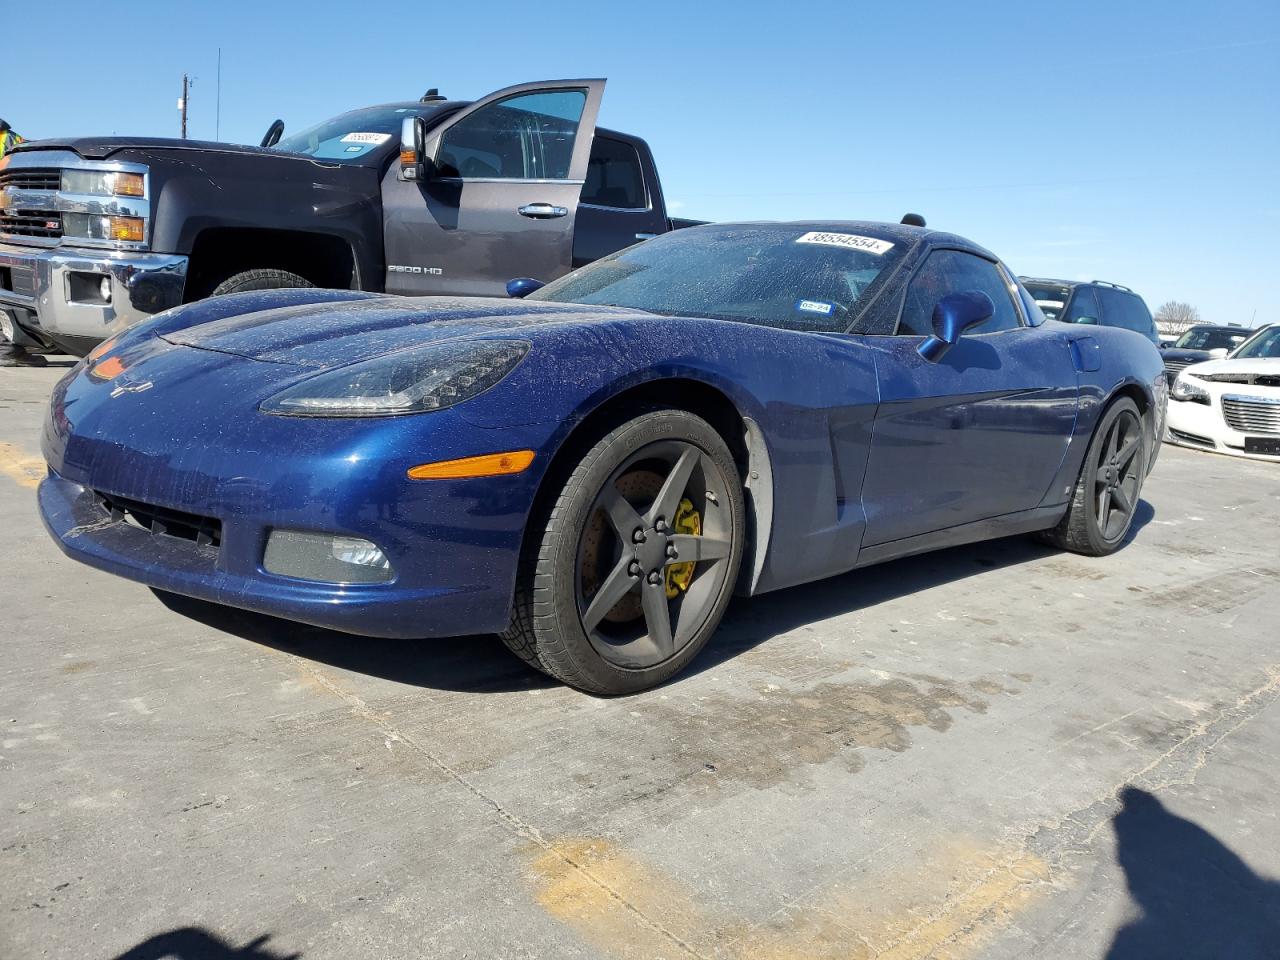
[0,243,187,355]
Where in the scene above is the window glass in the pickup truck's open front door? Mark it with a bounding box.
[436,90,586,180]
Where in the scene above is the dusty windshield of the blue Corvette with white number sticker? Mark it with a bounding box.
[530,225,906,332]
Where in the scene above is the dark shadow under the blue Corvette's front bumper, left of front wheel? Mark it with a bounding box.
[152,590,556,694]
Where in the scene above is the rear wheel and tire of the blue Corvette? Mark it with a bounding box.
[1039,397,1148,557]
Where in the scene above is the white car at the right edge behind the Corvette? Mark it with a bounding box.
[1165,324,1280,461]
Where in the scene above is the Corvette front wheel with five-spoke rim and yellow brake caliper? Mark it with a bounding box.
[503,410,745,695]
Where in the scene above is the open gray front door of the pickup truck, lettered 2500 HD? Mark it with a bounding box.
[383,79,604,296]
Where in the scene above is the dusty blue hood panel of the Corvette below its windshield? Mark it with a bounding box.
[163,296,650,370]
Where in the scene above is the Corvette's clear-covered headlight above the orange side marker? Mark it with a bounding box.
[261,340,530,417]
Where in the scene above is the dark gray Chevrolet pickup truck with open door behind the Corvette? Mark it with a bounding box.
[0,79,691,353]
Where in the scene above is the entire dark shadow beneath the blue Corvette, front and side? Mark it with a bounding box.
[152,500,1155,694]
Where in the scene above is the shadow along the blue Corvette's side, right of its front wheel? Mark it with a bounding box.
[681,500,1156,676]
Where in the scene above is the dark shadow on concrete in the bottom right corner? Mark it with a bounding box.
[1106,787,1280,960]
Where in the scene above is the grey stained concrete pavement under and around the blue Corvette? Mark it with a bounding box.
[0,369,1280,960]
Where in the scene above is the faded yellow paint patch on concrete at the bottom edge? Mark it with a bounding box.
[532,838,1051,960]
